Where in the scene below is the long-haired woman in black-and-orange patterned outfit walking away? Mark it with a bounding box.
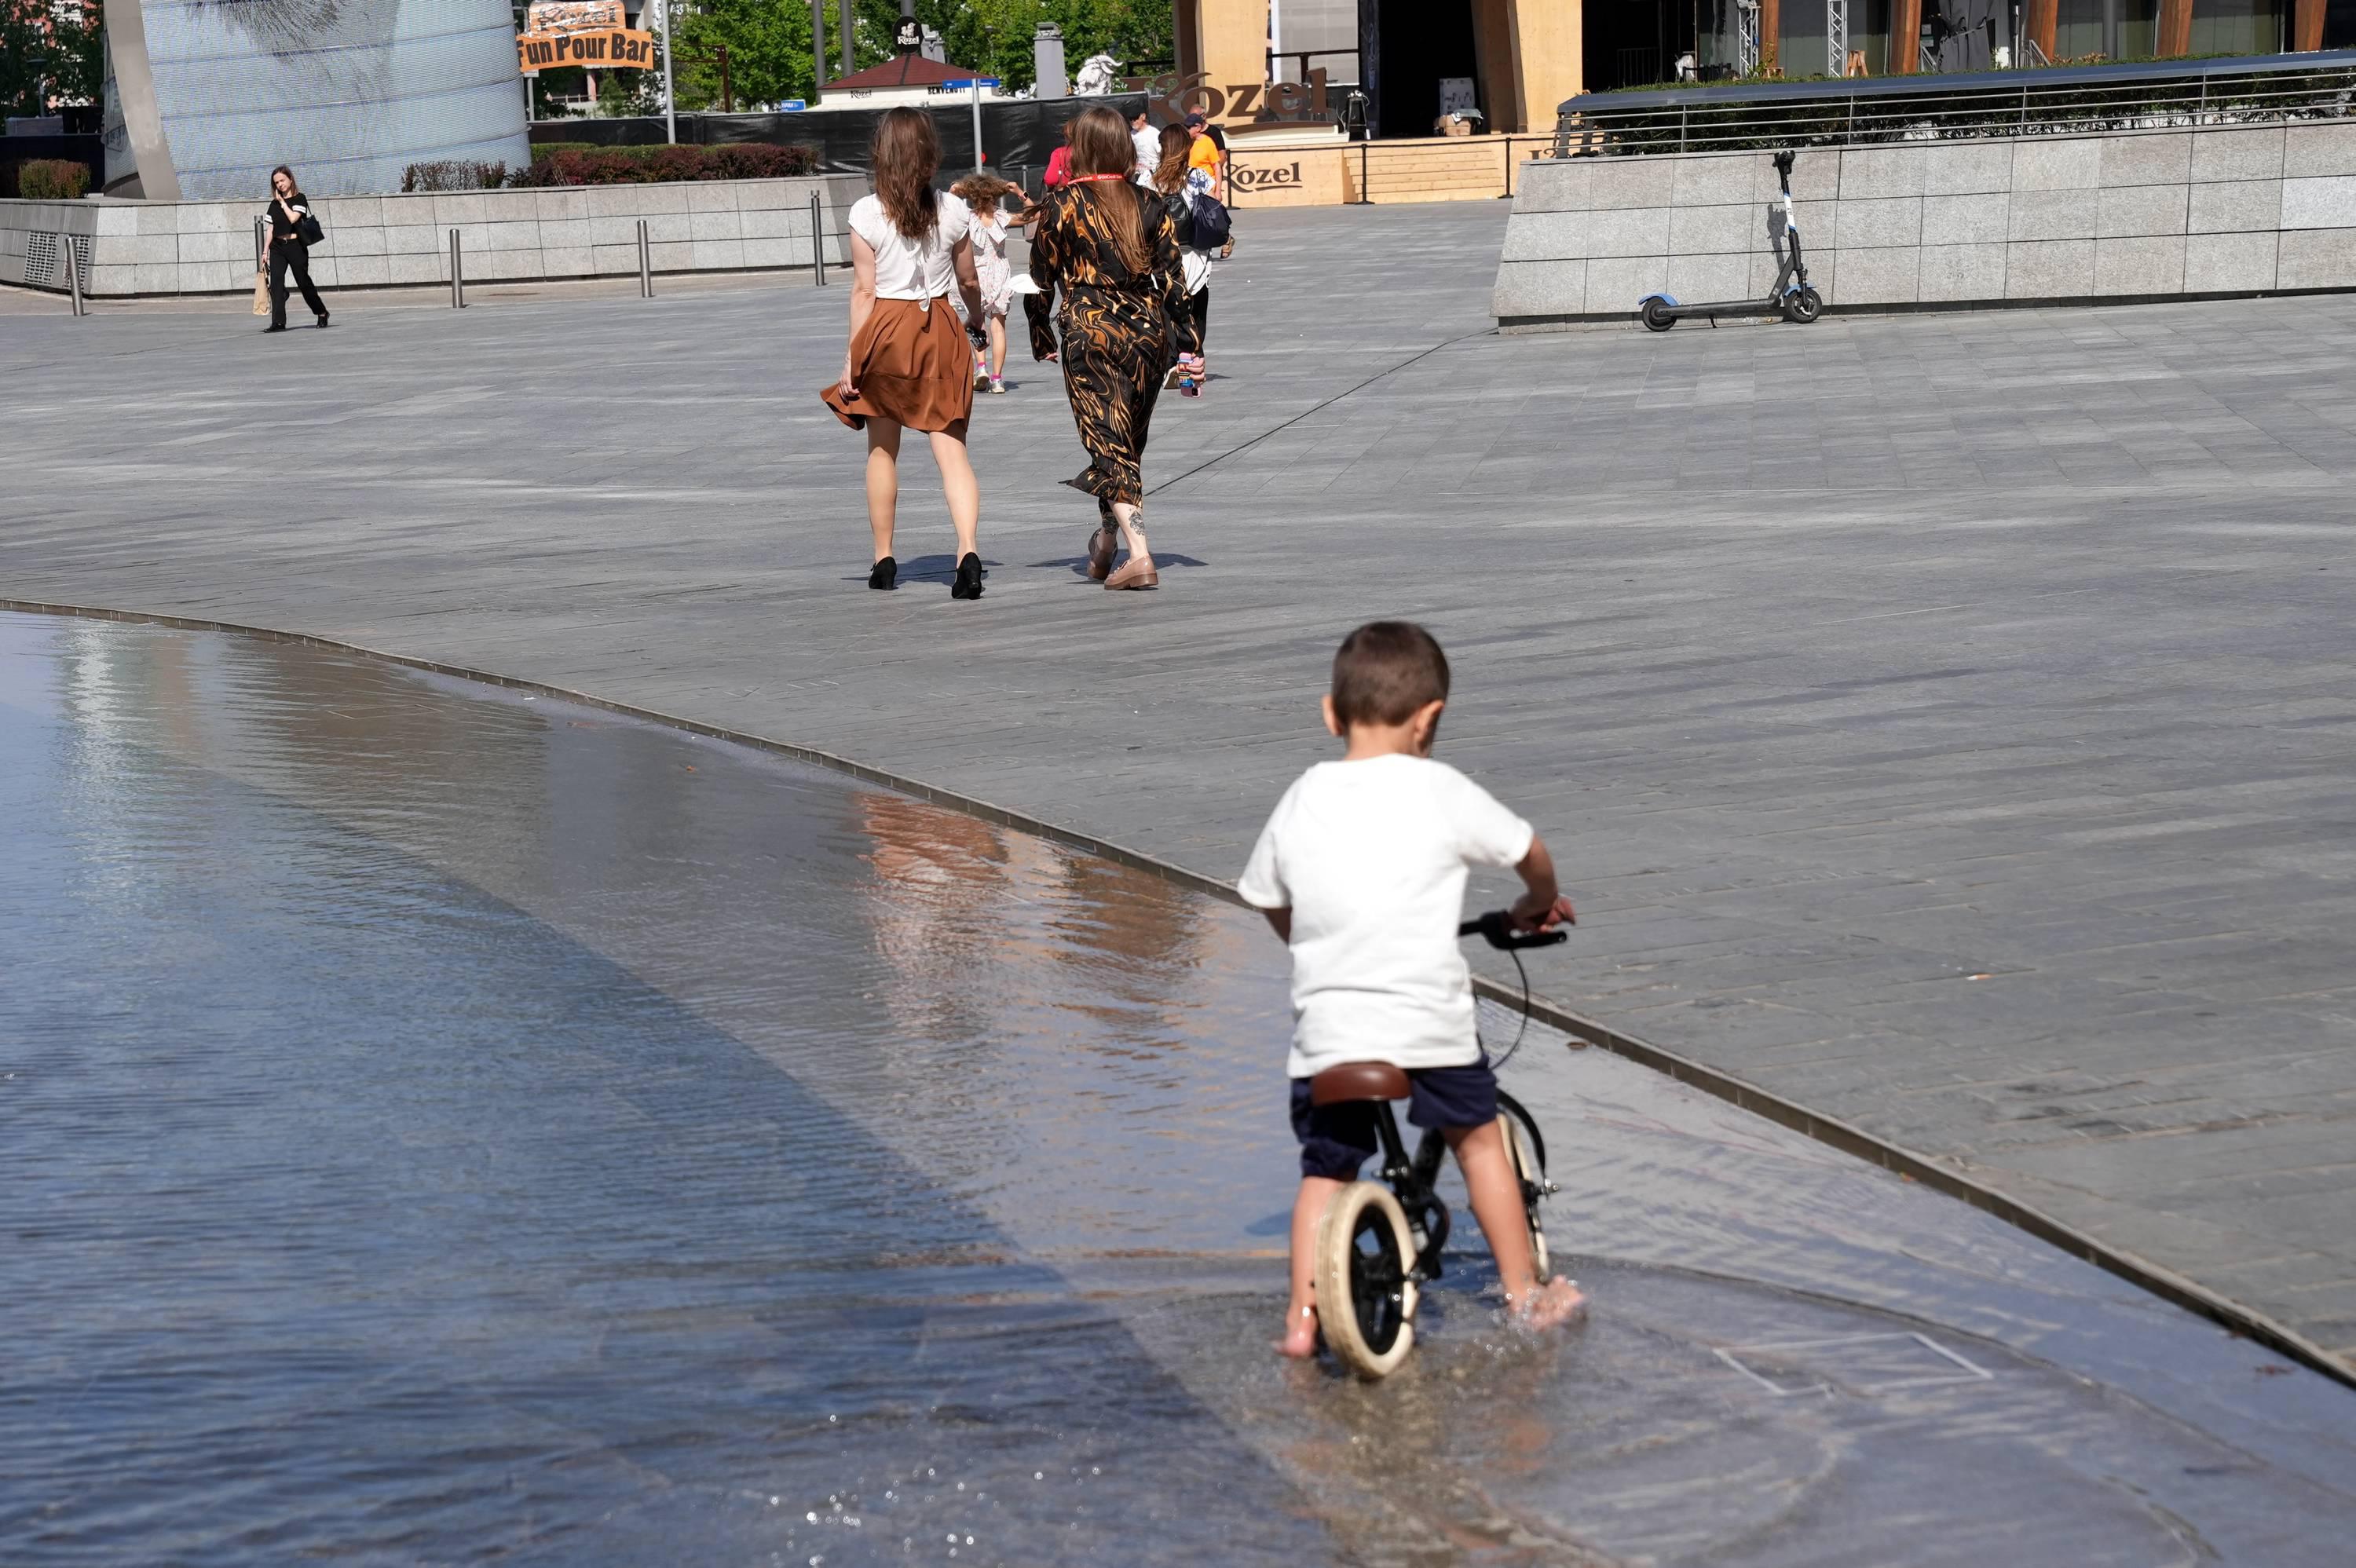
[1030,104,1202,589]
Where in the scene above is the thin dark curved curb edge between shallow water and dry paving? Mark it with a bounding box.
[0,596,2356,1389]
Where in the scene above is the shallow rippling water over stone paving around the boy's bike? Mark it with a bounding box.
[0,615,2356,1566]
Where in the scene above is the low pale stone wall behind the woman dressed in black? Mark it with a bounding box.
[0,174,867,299]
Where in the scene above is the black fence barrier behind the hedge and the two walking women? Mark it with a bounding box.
[532,92,1145,191]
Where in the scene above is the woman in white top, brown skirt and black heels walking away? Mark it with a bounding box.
[820,108,982,598]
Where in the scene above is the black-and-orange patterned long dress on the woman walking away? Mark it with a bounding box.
[1032,179,1202,506]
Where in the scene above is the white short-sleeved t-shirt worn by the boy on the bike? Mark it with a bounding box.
[1239,756,1534,1078]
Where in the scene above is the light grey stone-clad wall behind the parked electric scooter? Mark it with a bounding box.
[1494,120,2356,332]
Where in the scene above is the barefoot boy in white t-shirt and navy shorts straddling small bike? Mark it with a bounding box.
[1239,622,1583,1356]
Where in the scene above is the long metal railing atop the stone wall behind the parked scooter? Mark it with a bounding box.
[1553,52,2356,158]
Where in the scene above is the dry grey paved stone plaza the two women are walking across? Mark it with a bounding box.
[0,205,2356,1365]
